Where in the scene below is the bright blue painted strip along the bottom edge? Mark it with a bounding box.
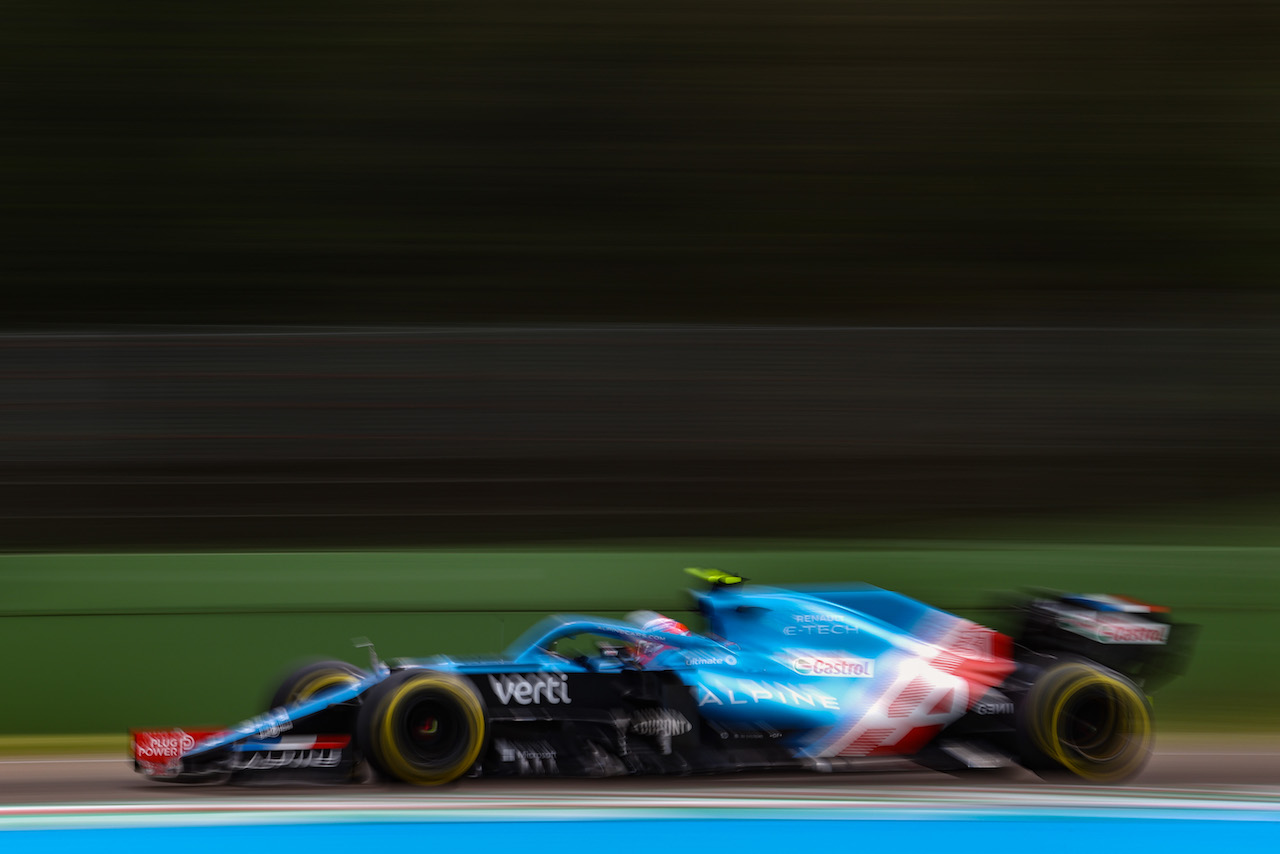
[0,816,1280,854]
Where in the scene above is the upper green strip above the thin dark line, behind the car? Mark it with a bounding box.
[0,540,1280,616]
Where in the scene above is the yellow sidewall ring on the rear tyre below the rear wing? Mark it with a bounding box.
[1034,666,1152,781]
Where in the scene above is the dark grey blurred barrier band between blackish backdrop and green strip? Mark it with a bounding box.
[0,325,1280,551]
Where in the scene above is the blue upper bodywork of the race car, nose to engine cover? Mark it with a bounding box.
[188,585,1012,757]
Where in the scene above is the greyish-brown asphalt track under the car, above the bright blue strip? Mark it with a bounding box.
[0,739,1280,810]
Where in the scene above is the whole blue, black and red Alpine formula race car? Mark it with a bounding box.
[132,570,1190,785]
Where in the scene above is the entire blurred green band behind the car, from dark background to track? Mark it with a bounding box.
[0,540,1280,734]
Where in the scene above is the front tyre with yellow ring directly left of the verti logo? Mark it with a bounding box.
[356,670,488,786]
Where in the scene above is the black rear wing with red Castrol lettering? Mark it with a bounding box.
[1012,592,1197,691]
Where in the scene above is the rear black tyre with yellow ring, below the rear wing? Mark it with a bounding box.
[1021,662,1155,782]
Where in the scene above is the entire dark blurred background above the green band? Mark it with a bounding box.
[0,0,1280,549]
